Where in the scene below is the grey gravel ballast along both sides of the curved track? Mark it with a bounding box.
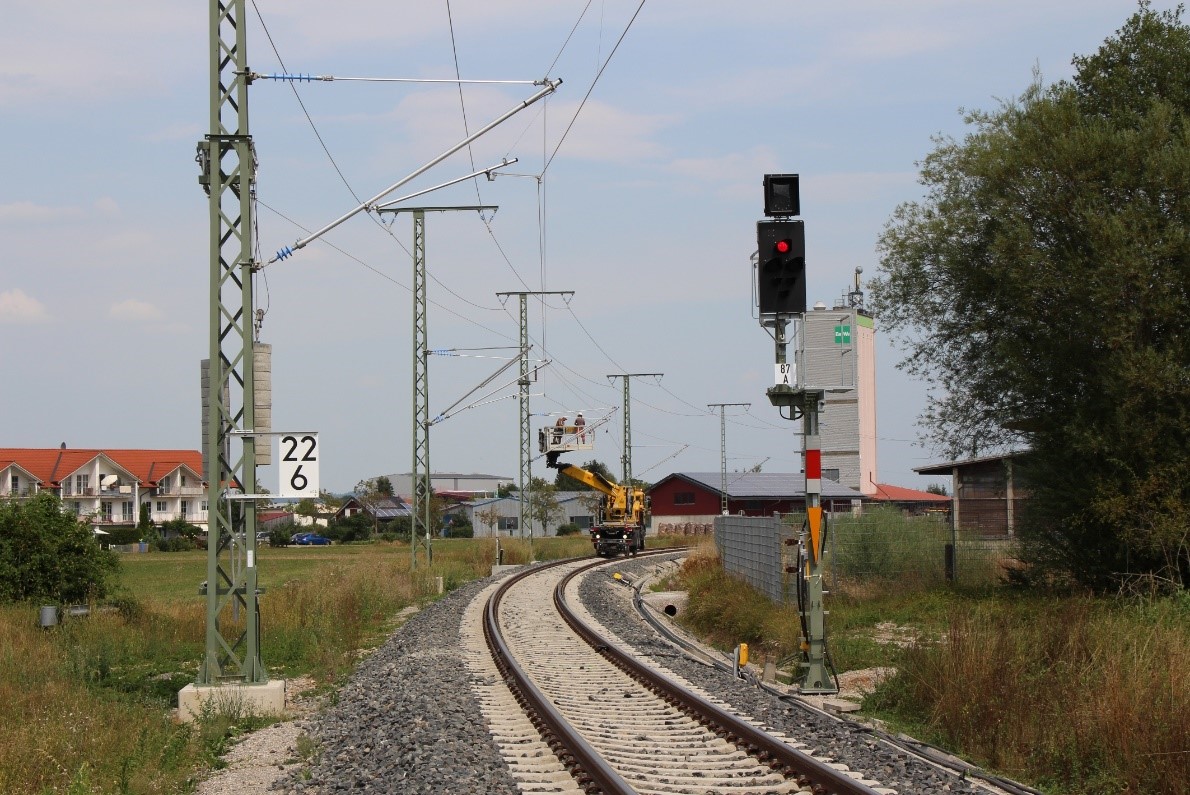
[274,558,1013,795]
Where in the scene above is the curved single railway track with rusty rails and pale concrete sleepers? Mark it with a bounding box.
[463,552,894,795]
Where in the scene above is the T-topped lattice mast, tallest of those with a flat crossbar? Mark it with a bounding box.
[376,205,499,570]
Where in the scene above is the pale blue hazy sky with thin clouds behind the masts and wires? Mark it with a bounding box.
[0,0,1173,490]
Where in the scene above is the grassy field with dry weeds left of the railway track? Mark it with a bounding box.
[0,537,590,795]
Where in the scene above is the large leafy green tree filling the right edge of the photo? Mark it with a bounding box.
[871,2,1190,588]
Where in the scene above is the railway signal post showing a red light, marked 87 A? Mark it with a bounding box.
[756,174,839,694]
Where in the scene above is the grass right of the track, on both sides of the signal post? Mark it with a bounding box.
[672,537,1190,795]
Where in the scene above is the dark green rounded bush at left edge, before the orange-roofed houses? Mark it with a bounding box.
[0,492,119,602]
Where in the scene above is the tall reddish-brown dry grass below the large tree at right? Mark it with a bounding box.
[871,597,1190,795]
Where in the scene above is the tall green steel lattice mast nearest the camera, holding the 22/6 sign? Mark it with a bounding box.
[195,0,262,686]
